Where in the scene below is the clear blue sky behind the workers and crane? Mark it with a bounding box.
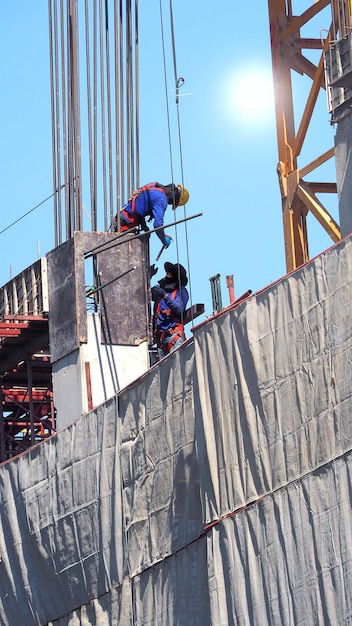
[0,0,338,315]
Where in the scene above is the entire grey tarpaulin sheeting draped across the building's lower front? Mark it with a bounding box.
[0,234,352,626]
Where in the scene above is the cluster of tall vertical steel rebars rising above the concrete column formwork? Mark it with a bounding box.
[48,0,140,238]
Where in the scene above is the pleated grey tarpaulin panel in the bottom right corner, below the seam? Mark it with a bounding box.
[208,453,352,626]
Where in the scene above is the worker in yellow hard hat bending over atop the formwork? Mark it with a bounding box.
[112,183,189,248]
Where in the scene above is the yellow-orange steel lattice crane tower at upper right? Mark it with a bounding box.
[268,0,341,272]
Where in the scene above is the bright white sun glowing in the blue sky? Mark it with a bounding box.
[224,64,275,127]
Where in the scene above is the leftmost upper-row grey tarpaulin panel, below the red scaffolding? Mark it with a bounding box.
[0,399,127,626]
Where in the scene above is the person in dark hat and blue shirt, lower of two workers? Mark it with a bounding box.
[152,262,189,359]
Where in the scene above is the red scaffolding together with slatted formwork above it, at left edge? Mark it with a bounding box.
[0,259,55,463]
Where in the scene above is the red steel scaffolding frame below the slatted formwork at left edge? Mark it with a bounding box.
[0,315,55,463]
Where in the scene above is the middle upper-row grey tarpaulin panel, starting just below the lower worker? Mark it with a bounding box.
[119,345,203,575]
